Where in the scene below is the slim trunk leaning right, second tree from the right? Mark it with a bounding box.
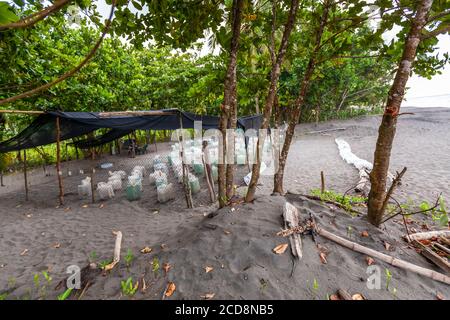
[273,1,330,194]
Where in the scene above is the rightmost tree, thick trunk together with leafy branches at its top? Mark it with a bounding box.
[368,0,450,226]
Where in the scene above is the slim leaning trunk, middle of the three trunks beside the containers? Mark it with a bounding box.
[245,0,299,202]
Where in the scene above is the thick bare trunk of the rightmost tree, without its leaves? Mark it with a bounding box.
[368,0,433,226]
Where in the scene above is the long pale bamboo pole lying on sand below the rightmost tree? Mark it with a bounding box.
[316,226,450,285]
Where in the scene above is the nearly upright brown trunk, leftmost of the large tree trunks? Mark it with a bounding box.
[218,0,244,208]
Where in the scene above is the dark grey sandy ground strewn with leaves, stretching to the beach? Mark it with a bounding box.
[0,108,450,299]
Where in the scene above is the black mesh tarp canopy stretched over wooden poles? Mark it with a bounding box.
[0,109,262,153]
